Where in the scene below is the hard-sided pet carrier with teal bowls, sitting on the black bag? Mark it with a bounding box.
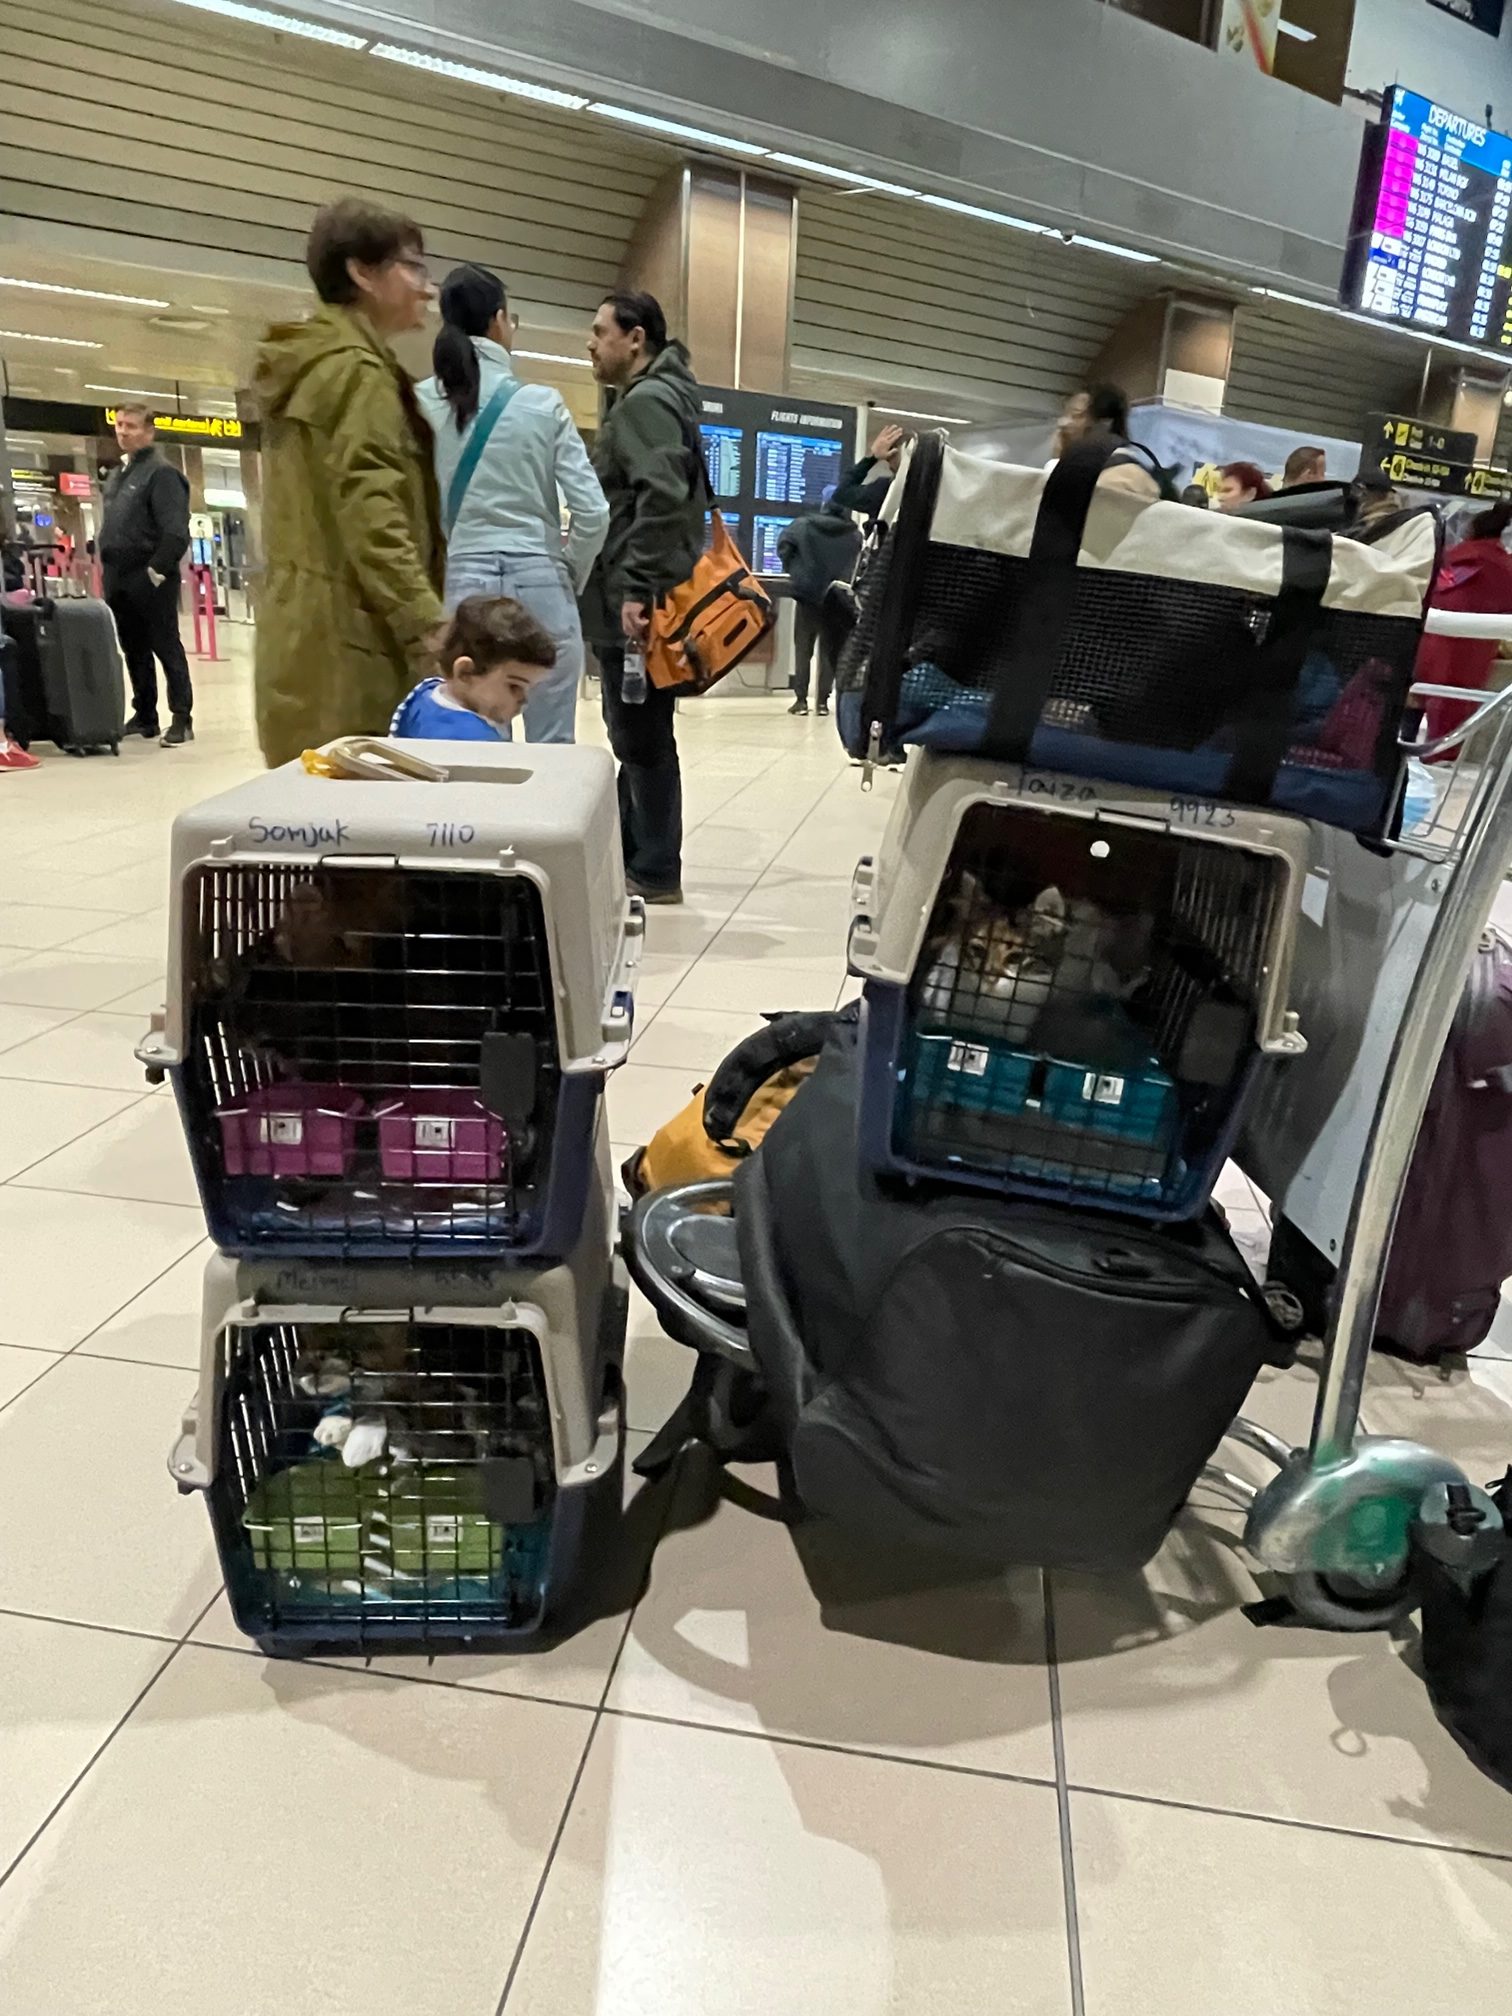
[849,756,1306,1218]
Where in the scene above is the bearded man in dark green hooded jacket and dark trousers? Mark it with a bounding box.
[583,292,706,903]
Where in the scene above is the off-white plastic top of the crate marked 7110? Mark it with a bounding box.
[151,742,645,1070]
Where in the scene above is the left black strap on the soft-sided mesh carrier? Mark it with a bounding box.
[982,433,1131,762]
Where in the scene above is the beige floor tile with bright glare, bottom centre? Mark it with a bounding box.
[510,1720,1080,2016]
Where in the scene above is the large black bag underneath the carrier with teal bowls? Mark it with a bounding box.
[736,1022,1274,1570]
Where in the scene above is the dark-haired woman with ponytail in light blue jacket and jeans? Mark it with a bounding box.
[417,266,609,742]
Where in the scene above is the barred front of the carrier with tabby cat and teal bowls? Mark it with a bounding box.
[867,804,1288,1216]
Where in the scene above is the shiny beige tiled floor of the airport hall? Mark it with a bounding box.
[0,649,1512,2016]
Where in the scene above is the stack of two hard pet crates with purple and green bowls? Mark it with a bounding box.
[154,744,641,1653]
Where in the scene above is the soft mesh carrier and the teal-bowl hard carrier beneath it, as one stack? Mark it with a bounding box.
[841,442,1437,1220]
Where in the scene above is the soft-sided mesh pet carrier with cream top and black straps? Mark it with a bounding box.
[839,435,1439,833]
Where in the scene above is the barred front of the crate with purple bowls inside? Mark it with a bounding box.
[179,861,568,1252]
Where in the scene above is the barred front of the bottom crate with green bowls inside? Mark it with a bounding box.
[210,1312,556,1649]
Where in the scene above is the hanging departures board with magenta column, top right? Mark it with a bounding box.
[1343,89,1512,351]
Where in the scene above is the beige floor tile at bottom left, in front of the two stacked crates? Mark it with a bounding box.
[0,1647,591,2016]
